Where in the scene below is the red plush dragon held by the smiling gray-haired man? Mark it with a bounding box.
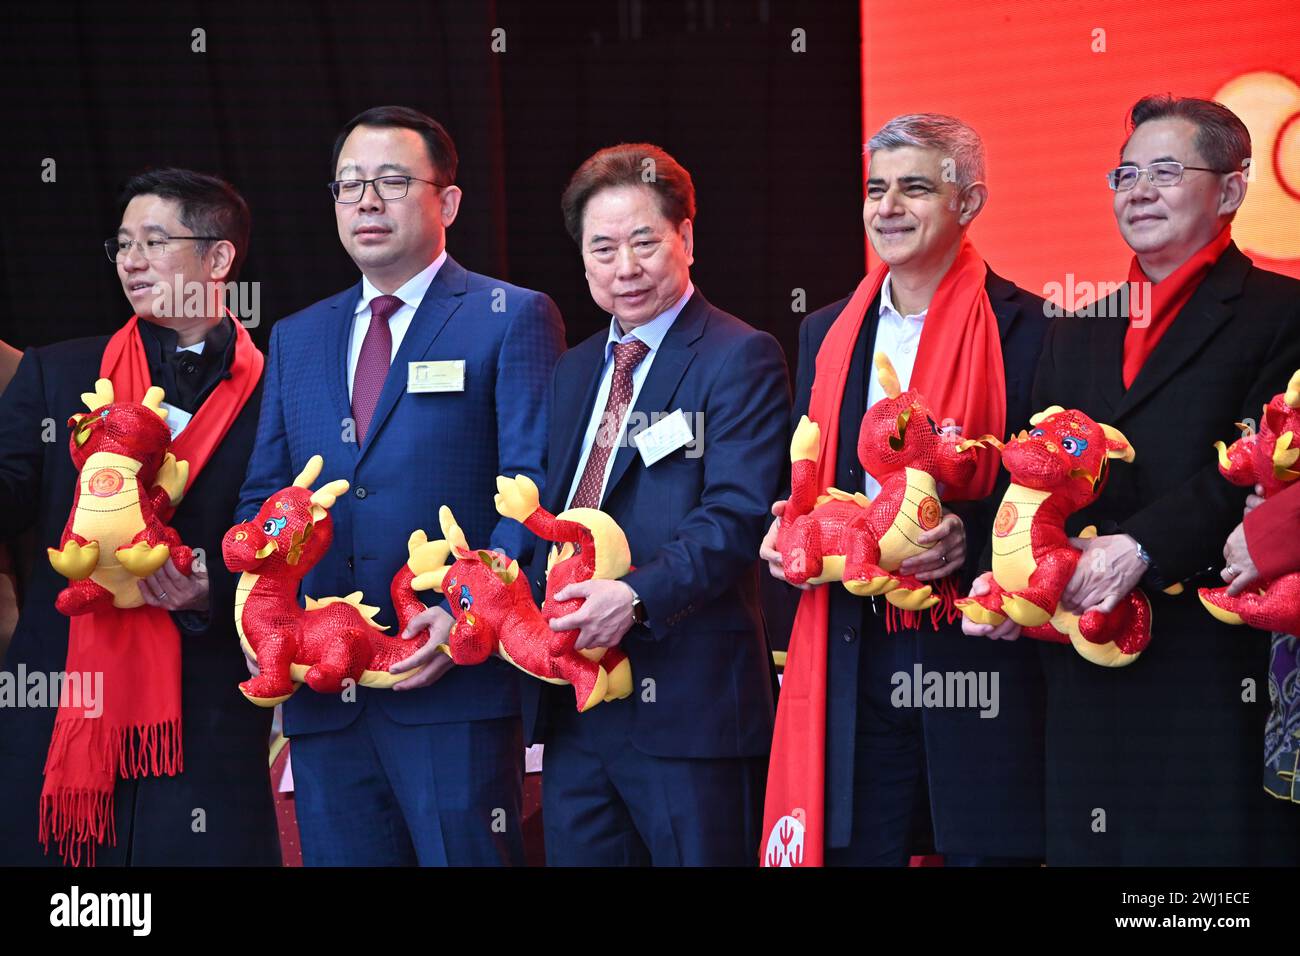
[776,352,982,611]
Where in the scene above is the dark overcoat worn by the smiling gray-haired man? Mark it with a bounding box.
[785,271,1049,857]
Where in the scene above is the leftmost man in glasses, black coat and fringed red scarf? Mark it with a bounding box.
[0,169,280,866]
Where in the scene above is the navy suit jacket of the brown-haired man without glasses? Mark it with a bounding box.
[523,290,790,757]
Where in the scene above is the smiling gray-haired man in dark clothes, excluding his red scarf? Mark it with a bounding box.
[761,113,1048,866]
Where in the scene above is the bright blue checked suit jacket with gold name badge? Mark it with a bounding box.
[235,256,564,735]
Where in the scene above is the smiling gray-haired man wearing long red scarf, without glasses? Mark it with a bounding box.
[761,113,1047,865]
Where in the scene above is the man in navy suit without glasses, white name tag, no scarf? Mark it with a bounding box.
[525,143,789,865]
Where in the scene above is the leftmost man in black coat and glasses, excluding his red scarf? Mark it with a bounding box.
[0,169,280,865]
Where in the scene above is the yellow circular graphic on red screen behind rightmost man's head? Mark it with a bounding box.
[1213,70,1300,260]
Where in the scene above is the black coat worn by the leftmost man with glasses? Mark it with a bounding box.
[0,337,280,865]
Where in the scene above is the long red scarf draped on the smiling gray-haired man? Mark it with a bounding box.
[759,241,1006,866]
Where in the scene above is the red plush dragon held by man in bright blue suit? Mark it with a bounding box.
[221,455,447,708]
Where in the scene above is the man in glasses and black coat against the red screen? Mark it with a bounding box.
[965,96,1300,866]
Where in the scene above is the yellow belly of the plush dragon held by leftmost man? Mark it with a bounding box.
[73,451,144,607]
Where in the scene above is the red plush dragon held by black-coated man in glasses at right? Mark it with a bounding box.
[957,405,1151,667]
